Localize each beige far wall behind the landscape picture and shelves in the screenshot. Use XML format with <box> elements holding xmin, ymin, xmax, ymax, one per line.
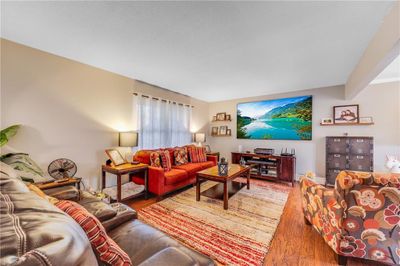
<box><xmin>208</xmin><ymin>82</ymin><xmax>400</xmax><ymax>179</ymax></box>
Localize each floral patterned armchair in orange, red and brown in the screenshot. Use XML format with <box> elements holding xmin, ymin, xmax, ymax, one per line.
<box><xmin>300</xmin><ymin>171</ymin><xmax>400</xmax><ymax>265</ymax></box>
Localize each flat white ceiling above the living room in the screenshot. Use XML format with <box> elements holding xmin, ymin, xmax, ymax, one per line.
<box><xmin>1</xmin><ymin>1</ymin><xmax>393</xmax><ymax>101</ymax></box>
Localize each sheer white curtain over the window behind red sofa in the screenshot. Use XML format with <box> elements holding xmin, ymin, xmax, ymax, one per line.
<box><xmin>133</xmin><ymin>95</ymin><xmax>191</xmax><ymax>149</ymax></box>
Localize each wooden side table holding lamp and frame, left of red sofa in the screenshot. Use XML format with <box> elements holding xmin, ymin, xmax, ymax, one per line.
<box><xmin>101</xmin><ymin>163</ymin><xmax>148</xmax><ymax>202</ymax></box>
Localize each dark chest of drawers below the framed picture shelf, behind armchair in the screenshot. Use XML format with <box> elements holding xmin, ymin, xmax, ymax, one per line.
<box><xmin>326</xmin><ymin>136</ymin><xmax>374</xmax><ymax>186</ymax></box>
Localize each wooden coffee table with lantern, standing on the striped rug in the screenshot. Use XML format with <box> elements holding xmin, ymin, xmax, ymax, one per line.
<box><xmin>196</xmin><ymin>164</ymin><xmax>251</xmax><ymax>210</ymax></box>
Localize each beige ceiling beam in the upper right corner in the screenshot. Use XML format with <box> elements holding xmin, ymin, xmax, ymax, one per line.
<box><xmin>346</xmin><ymin>1</ymin><xmax>400</xmax><ymax>99</ymax></box>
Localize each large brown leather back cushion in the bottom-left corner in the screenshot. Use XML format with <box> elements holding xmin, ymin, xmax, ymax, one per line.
<box><xmin>0</xmin><ymin>173</ymin><xmax>97</xmax><ymax>266</ymax></box>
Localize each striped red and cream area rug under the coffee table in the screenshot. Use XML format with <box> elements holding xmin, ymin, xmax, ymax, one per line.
<box><xmin>139</xmin><ymin>179</ymin><xmax>291</xmax><ymax>265</ymax></box>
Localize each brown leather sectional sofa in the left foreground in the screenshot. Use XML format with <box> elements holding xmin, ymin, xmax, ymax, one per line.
<box><xmin>0</xmin><ymin>172</ymin><xmax>215</xmax><ymax>266</ymax></box>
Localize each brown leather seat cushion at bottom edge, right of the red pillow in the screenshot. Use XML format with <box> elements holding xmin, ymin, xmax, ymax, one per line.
<box><xmin>108</xmin><ymin>220</ymin><xmax>215</xmax><ymax>266</ymax></box>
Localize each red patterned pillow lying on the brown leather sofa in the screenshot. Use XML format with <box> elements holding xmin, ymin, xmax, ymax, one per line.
<box><xmin>56</xmin><ymin>200</ymin><xmax>132</xmax><ymax>266</ymax></box>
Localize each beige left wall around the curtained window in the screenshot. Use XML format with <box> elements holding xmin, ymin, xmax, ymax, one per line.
<box><xmin>1</xmin><ymin>40</ymin><xmax>208</xmax><ymax>187</ymax></box>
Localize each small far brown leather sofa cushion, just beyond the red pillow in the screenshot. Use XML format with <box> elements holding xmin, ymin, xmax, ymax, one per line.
<box><xmin>78</xmin><ymin>191</ymin><xmax>117</xmax><ymax>222</ymax></box>
